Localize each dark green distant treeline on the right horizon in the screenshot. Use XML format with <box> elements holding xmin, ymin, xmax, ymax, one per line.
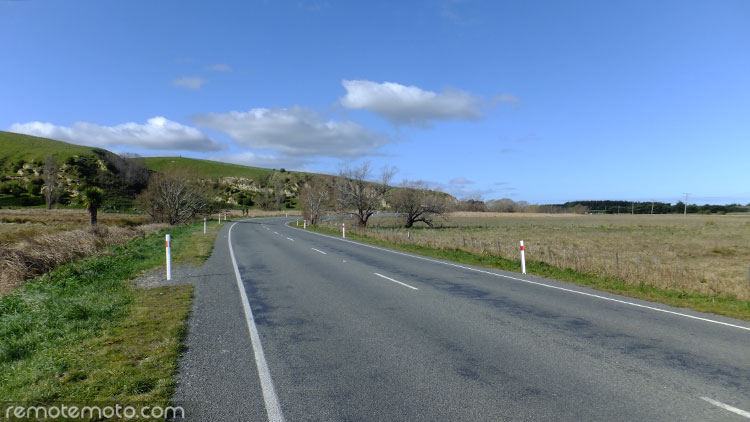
<box><xmin>560</xmin><ymin>201</ymin><xmax>750</xmax><ymax>214</ymax></box>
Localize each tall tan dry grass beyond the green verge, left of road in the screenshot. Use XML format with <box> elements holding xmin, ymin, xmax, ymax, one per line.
<box><xmin>0</xmin><ymin>224</ymin><xmax>165</xmax><ymax>294</ymax></box>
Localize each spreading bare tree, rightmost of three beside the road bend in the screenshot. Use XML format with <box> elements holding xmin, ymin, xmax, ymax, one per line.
<box><xmin>391</xmin><ymin>180</ymin><xmax>448</xmax><ymax>228</ymax></box>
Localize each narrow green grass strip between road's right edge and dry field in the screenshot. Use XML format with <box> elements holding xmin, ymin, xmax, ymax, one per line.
<box><xmin>308</xmin><ymin>226</ymin><xmax>750</xmax><ymax>321</ymax></box>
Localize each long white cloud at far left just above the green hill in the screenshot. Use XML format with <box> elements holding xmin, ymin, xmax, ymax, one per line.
<box><xmin>9</xmin><ymin>117</ymin><xmax>223</xmax><ymax>151</ymax></box>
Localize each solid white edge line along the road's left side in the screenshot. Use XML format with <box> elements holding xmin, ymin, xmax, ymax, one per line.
<box><xmin>227</xmin><ymin>223</ymin><xmax>284</xmax><ymax>422</ymax></box>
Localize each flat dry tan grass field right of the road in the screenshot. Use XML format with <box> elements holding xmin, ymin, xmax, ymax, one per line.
<box><xmin>326</xmin><ymin>212</ymin><xmax>750</xmax><ymax>299</ymax></box>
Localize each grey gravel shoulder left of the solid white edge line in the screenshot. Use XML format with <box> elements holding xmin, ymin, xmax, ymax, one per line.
<box><xmin>170</xmin><ymin>224</ymin><xmax>266</xmax><ymax>421</ymax></box>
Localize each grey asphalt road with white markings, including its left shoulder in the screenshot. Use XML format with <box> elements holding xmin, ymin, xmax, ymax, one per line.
<box><xmin>175</xmin><ymin>219</ymin><xmax>750</xmax><ymax>421</ymax></box>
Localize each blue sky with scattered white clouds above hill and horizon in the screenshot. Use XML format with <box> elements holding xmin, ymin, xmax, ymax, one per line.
<box><xmin>0</xmin><ymin>0</ymin><xmax>750</xmax><ymax>203</ymax></box>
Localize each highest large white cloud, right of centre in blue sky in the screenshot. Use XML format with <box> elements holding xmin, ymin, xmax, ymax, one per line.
<box><xmin>341</xmin><ymin>80</ymin><xmax>481</xmax><ymax>127</ymax></box>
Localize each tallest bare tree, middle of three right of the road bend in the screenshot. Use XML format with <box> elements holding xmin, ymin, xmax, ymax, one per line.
<box><xmin>336</xmin><ymin>162</ymin><xmax>396</xmax><ymax>227</ymax></box>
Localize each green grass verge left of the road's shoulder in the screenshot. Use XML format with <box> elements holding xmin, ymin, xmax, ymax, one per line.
<box><xmin>0</xmin><ymin>222</ymin><xmax>218</xmax><ymax>414</ymax></box>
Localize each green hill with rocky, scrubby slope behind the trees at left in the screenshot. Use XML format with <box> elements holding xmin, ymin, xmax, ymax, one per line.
<box><xmin>0</xmin><ymin>131</ymin><xmax>308</xmax><ymax>209</ymax></box>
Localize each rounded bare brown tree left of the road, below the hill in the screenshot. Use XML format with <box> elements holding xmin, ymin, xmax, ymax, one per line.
<box><xmin>137</xmin><ymin>170</ymin><xmax>211</xmax><ymax>225</ymax></box>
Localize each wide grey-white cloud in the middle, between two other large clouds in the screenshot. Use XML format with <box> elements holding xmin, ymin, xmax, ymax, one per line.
<box><xmin>193</xmin><ymin>106</ymin><xmax>392</xmax><ymax>157</ymax></box>
